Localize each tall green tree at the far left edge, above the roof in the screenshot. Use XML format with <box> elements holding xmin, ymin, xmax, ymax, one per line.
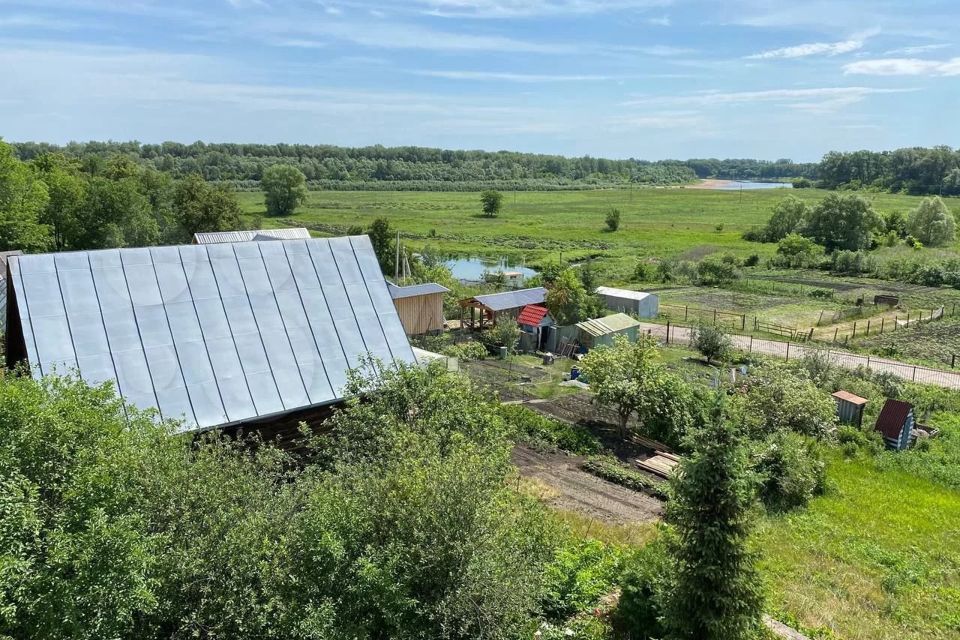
<box><xmin>0</xmin><ymin>140</ymin><xmax>51</xmax><ymax>251</ymax></box>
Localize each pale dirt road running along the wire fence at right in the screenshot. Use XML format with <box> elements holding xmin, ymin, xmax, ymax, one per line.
<box><xmin>640</xmin><ymin>322</ymin><xmax>960</xmax><ymax>389</ymax></box>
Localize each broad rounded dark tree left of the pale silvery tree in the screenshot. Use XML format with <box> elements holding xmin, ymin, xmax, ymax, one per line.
<box><xmin>801</xmin><ymin>193</ymin><xmax>884</xmax><ymax>252</ymax></box>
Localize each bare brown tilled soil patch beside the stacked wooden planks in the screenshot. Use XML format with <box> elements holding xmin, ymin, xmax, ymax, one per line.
<box><xmin>513</xmin><ymin>447</ymin><xmax>663</xmax><ymax>524</ymax></box>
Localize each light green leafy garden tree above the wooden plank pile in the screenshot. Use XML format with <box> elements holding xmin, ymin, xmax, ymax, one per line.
<box><xmin>580</xmin><ymin>335</ymin><xmax>695</xmax><ymax>444</ymax></box>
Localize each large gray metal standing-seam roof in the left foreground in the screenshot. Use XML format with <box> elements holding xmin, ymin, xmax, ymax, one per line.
<box><xmin>10</xmin><ymin>236</ymin><xmax>414</xmax><ymax>429</ymax></box>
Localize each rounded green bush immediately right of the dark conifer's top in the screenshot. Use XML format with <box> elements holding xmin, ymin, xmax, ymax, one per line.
<box><xmin>753</xmin><ymin>432</ymin><xmax>826</xmax><ymax>511</ymax></box>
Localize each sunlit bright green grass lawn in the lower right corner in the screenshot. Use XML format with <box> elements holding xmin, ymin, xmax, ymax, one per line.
<box><xmin>759</xmin><ymin>458</ymin><xmax>960</xmax><ymax>640</ymax></box>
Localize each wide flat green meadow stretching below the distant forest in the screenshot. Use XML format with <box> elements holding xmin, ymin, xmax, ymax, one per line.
<box><xmin>239</xmin><ymin>188</ymin><xmax>932</xmax><ymax>275</ymax></box>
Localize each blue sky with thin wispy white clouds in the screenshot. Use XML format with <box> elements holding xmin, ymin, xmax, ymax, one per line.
<box><xmin>0</xmin><ymin>0</ymin><xmax>960</xmax><ymax>161</ymax></box>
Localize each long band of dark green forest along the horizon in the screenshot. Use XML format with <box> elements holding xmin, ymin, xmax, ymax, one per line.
<box><xmin>13</xmin><ymin>142</ymin><xmax>960</xmax><ymax>195</ymax></box>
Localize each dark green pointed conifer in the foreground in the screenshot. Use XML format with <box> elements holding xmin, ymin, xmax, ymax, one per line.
<box><xmin>664</xmin><ymin>396</ymin><xmax>763</xmax><ymax>640</ymax></box>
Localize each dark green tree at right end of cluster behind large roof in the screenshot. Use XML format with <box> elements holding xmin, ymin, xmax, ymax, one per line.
<box><xmin>173</xmin><ymin>173</ymin><xmax>241</xmax><ymax>242</ymax></box>
